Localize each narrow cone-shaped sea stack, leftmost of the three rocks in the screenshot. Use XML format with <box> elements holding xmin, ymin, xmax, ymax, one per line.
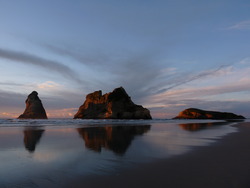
<box><xmin>18</xmin><ymin>91</ymin><xmax>48</xmax><ymax>119</ymax></box>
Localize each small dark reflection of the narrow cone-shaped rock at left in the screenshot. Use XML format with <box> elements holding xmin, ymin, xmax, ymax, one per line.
<box><xmin>23</xmin><ymin>128</ymin><xmax>44</xmax><ymax>152</ymax></box>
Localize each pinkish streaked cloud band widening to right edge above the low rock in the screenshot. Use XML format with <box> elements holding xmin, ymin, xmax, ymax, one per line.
<box><xmin>150</xmin><ymin>64</ymin><xmax>250</xmax><ymax>103</ymax></box>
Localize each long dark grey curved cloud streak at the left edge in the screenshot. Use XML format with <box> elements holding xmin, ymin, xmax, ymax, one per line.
<box><xmin>0</xmin><ymin>48</ymin><xmax>83</xmax><ymax>83</ymax></box>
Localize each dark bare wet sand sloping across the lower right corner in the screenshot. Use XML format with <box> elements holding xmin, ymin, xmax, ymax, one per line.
<box><xmin>65</xmin><ymin>123</ymin><xmax>250</xmax><ymax>188</ymax></box>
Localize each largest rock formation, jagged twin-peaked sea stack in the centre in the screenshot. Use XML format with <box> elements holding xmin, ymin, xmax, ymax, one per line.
<box><xmin>74</xmin><ymin>87</ymin><xmax>152</xmax><ymax>119</ymax></box>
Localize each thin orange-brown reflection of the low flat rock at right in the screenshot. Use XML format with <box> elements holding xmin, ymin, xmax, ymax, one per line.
<box><xmin>179</xmin><ymin>122</ymin><xmax>228</xmax><ymax>131</ymax></box>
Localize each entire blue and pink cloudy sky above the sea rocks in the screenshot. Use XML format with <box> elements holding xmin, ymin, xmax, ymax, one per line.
<box><xmin>0</xmin><ymin>0</ymin><xmax>250</xmax><ymax>118</ymax></box>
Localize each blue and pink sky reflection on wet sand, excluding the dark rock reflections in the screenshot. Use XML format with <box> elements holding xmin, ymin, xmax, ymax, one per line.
<box><xmin>0</xmin><ymin>123</ymin><xmax>236</xmax><ymax>187</ymax></box>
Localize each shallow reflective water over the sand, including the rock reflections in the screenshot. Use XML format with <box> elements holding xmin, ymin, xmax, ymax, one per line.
<box><xmin>0</xmin><ymin>119</ymin><xmax>237</xmax><ymax>188</ymax></box>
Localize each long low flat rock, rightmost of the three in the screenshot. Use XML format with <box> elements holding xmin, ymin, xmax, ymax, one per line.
<box><xmin>174</xmin><ymin>108</ymin><xmax>245</xmax><ymax>120</ymax></box>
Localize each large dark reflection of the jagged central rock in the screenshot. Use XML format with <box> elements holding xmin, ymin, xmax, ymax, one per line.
<box><xmin>77</xmin><ymin>125</ymin><xmax>150</xmax><ymax>155</ymax></box>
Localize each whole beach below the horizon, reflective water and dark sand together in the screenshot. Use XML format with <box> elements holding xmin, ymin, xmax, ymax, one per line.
<box><xmin>0</xmin><ymin>119</ymin><xmax>250</xmax><ymax>188</ymax></box>
